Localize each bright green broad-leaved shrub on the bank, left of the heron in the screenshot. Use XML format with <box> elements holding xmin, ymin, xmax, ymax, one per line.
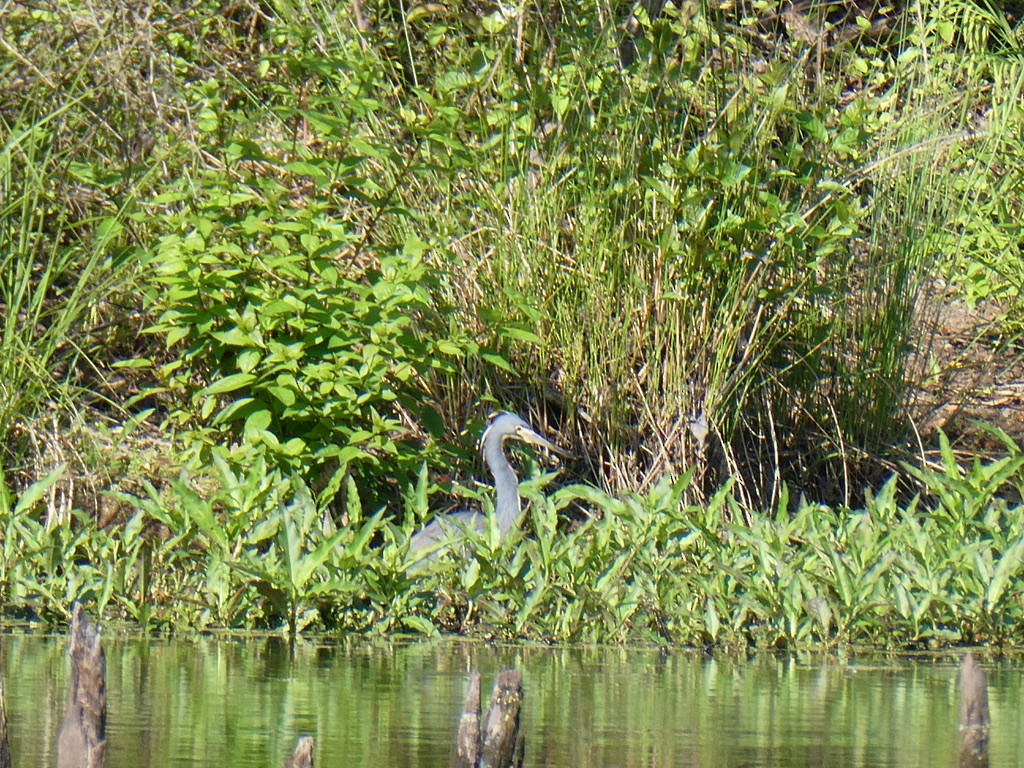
<box><xmin>142</xmin><ymin>134</ymin><xmax>469</xmax><ymax>507</ymax></box>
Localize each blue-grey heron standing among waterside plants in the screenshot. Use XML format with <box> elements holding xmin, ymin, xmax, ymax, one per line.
<box><xmin>409</xmin><ymin>413</ymin><xmax>566</xmax><ymax>562</ymax></box>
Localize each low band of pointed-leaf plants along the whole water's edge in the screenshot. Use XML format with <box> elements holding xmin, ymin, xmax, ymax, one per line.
<box><xmin>12</xmin><ymin>436</ymin><xmax>1024</xmax><ymax>650</ymax></box>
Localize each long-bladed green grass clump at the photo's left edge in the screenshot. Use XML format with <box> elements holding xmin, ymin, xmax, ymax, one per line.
<box><xmin>0</xmin><ymin>104</ymin><xmax>133</xmax><ymax>473</ymax></box>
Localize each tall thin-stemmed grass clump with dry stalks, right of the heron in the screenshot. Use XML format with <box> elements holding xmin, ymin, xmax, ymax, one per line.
<box><xmin>397</xmin><ymin>4</ymin><xmax>974</xmax><ymax>506</ymax></box>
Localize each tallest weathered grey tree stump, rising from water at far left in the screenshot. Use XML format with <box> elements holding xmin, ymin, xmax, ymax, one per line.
<box><xmin>57</xmin><ymin>603</ymin><xmax>106</xmax><ymax>768</ymax></box>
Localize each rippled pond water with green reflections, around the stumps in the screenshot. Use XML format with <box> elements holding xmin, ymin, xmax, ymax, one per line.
<box><xmin>0</xmin><ymin>636</ymin><xmax>1024</xmax><ymax>768</ymax></box>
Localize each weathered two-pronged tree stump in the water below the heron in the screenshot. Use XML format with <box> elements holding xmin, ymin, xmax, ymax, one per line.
<box><xmin>452</xmin><ymin>670</ymin><xmax>525</xmax><ymax>768</ymax></box>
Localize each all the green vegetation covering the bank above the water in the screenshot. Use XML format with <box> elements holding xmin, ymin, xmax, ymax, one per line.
<box><xmin>0</xmin><ymin>0</ymin><xmax>1024</xmax><ymax>647</ymax></box>
